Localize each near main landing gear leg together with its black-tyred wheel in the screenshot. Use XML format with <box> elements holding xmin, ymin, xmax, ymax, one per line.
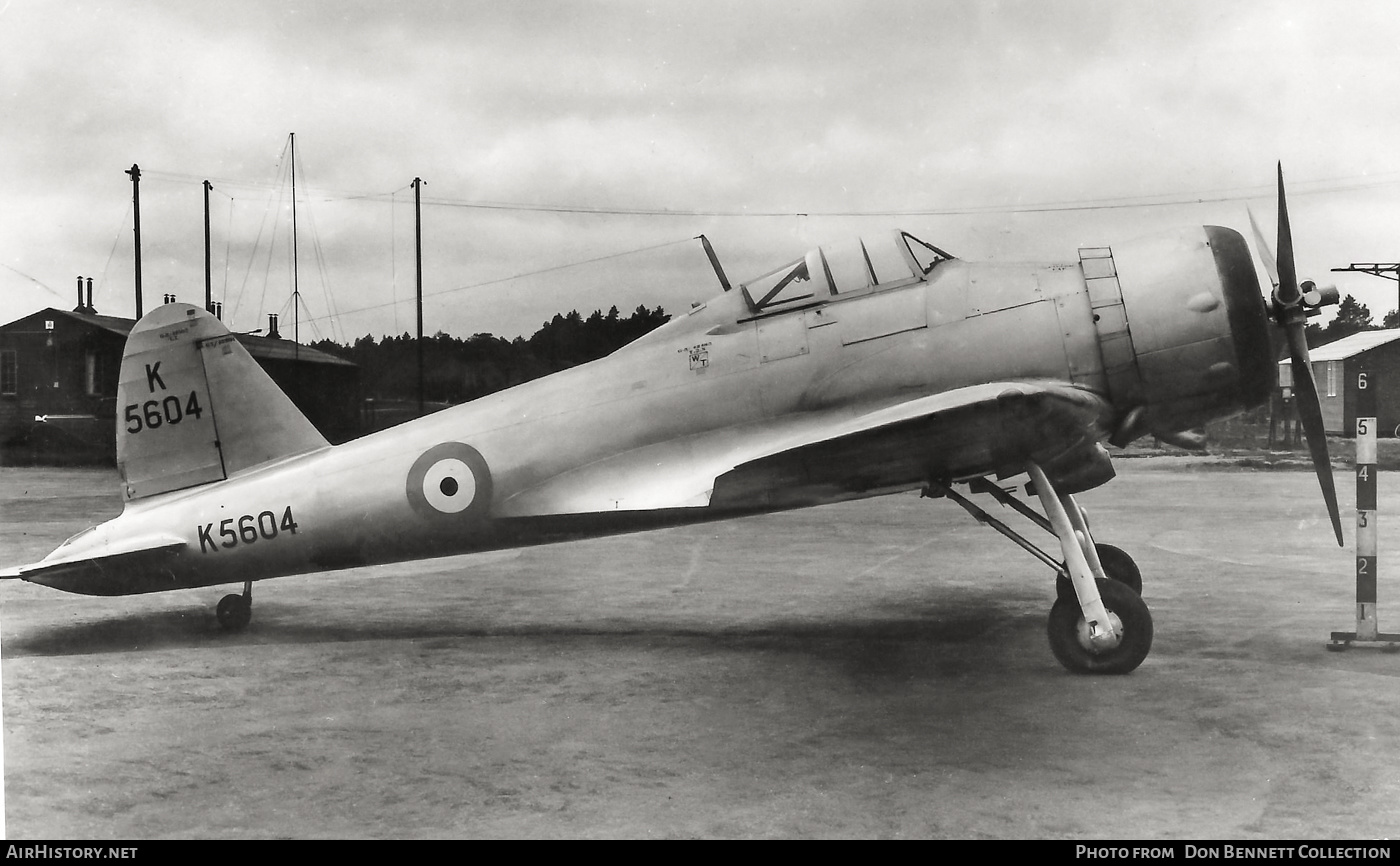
<box><xmin>1026</xmin><ymin>463</ymin><xmax>1152</xmax><ymax>673</ymax></box>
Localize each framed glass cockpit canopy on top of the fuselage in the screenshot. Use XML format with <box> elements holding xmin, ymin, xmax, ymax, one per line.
<box><xmin>741</xmin><ymin>231</ymin><xmax>953</xmax><ymax>315</ymax></box>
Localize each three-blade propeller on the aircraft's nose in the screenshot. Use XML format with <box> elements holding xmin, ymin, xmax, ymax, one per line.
<box><xmin>1249</xmin><ymin>162</ymin><xmax>1343</xmax><ymax>546</ymax></box>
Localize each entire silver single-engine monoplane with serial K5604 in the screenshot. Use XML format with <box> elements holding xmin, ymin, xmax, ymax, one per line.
<box><xmin>0</xmin><ymin>169</ymin><xmax>1341</xmax><ymax>673</ymax></box>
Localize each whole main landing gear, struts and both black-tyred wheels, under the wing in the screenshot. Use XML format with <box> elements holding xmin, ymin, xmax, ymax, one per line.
<box><xmin>924</xmin><ymin>463</ymin><xmax>1152</xmax><ymax>673</ymax></box>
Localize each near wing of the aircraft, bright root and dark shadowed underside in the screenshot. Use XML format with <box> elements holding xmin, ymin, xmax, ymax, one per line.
<box><xmin>496</xmin><ymin>382</ymin><xmax>1112</xmax><ymax>518</ymax></box>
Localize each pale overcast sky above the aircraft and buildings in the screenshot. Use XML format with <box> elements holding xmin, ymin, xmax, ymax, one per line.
<box><xmin>0</xmin><ymin>0</ymin><xmax>1400</xmax><ymax>341</ymax></box>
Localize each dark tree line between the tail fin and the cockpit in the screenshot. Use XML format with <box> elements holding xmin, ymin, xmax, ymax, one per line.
<box><xmin>312</xmin><ymin>306</ymin><xmax>671</xmax><ymax>404</ymax></box>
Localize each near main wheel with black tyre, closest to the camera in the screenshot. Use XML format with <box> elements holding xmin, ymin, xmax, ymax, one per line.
<box><xmin>1046</xmin><ymin>579</ymin><xmax>1152</xmax><ymax>673</ymax></box>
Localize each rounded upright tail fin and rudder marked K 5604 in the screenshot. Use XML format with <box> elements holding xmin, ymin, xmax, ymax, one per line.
<box><xmin>116</xmin><ymin>304</ymin><xmax>329</xmax><ymax>501</ymax></box>
